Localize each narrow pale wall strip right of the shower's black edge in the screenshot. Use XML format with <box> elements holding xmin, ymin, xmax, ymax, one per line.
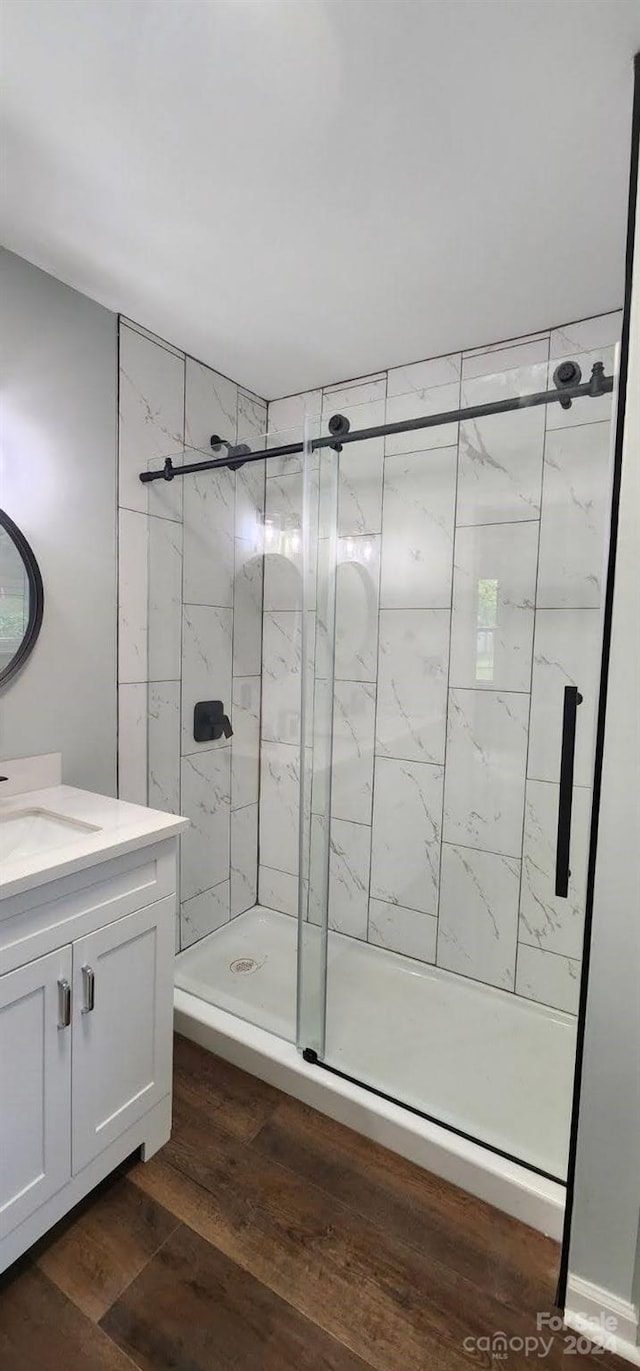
<box><xmin>567</xmin><ymin>150</ymin><xmax>640</xmax><ymax>1327</ymax></box>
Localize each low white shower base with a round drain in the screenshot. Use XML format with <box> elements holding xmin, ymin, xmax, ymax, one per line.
<box><xmin>175</xmin><ymin>906</ymin><xmax>576</xmax><ymax>1238</ymax></box>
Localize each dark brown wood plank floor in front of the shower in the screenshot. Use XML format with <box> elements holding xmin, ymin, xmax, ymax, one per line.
<box><xmin>0</xmin><ymin>1038</ymin><xmax>625</xmax><ymax>1371</ymax></box>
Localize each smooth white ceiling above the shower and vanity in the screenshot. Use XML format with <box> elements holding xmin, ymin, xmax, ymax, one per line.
<box><xmin>0</xmin><ymin>0</ymin><xmax>640</xmax><ymax>398</ymax></box>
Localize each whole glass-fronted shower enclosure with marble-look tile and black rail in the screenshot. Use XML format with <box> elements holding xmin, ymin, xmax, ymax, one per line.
<box><xmin>139</xmin><ymin>314</ymin><xmax>621</xmax><ymax>1200</ymax></box>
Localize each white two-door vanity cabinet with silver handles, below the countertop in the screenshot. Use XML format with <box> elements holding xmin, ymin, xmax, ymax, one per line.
<box><xmin>0</xmin><ymin>802</ymin><xmax>182</xmax><ymax>1271</ymax></box>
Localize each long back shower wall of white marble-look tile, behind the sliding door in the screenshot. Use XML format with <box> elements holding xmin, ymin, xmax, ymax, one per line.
<box><xmin>260</xmin><ymin>313</ymin><xmax>621</xmax><ymax>1013</ymax></box>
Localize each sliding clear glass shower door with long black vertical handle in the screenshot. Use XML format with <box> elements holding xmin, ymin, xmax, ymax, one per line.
<box><xmin>313</xmin><ymin>335</ymin><xmax>619</xmax><ymax>1179</ymax></box>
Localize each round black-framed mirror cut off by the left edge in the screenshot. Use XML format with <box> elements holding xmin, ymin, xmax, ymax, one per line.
<box><xmin>0</xmin><ymin>509</ymin><xmax>44</xmax><ymax>687</ymax></box>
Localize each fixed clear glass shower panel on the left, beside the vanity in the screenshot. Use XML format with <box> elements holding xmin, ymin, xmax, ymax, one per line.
<box><xmin>169</xmin><ymin>414</ymin><xmax>312</xmax><ymax>1041</ymax></box>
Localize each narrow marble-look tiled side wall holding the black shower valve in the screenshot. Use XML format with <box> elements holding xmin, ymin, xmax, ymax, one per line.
<box><xmin>118</xmin><ymin>321</ymin><xmax>266</xmax><ymax>949</ymax></box>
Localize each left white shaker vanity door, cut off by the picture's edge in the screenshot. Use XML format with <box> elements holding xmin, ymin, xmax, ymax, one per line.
<box><xmin>0</xmin><ymin>946</ymin><xmax>71</xmax><ymax>1239</ymax></box>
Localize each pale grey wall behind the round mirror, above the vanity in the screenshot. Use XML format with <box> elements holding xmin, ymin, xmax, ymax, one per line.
<box><xmin>0</xmin><ymin>250</ymin><xmax>116</xmax><ymax>794</ymax></box>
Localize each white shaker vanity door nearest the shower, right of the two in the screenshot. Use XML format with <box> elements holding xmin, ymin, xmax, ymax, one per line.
<box><xmin>73</xmin><ymin>895</ymin><xmax>175</xmax><ymax>1175</ymax></box>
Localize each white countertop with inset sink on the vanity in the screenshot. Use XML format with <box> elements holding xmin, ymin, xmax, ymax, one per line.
<box><xmin>0</xmin><ymin>786</ymin><xmax>189</xmax><ymax>899</ymax></box>
